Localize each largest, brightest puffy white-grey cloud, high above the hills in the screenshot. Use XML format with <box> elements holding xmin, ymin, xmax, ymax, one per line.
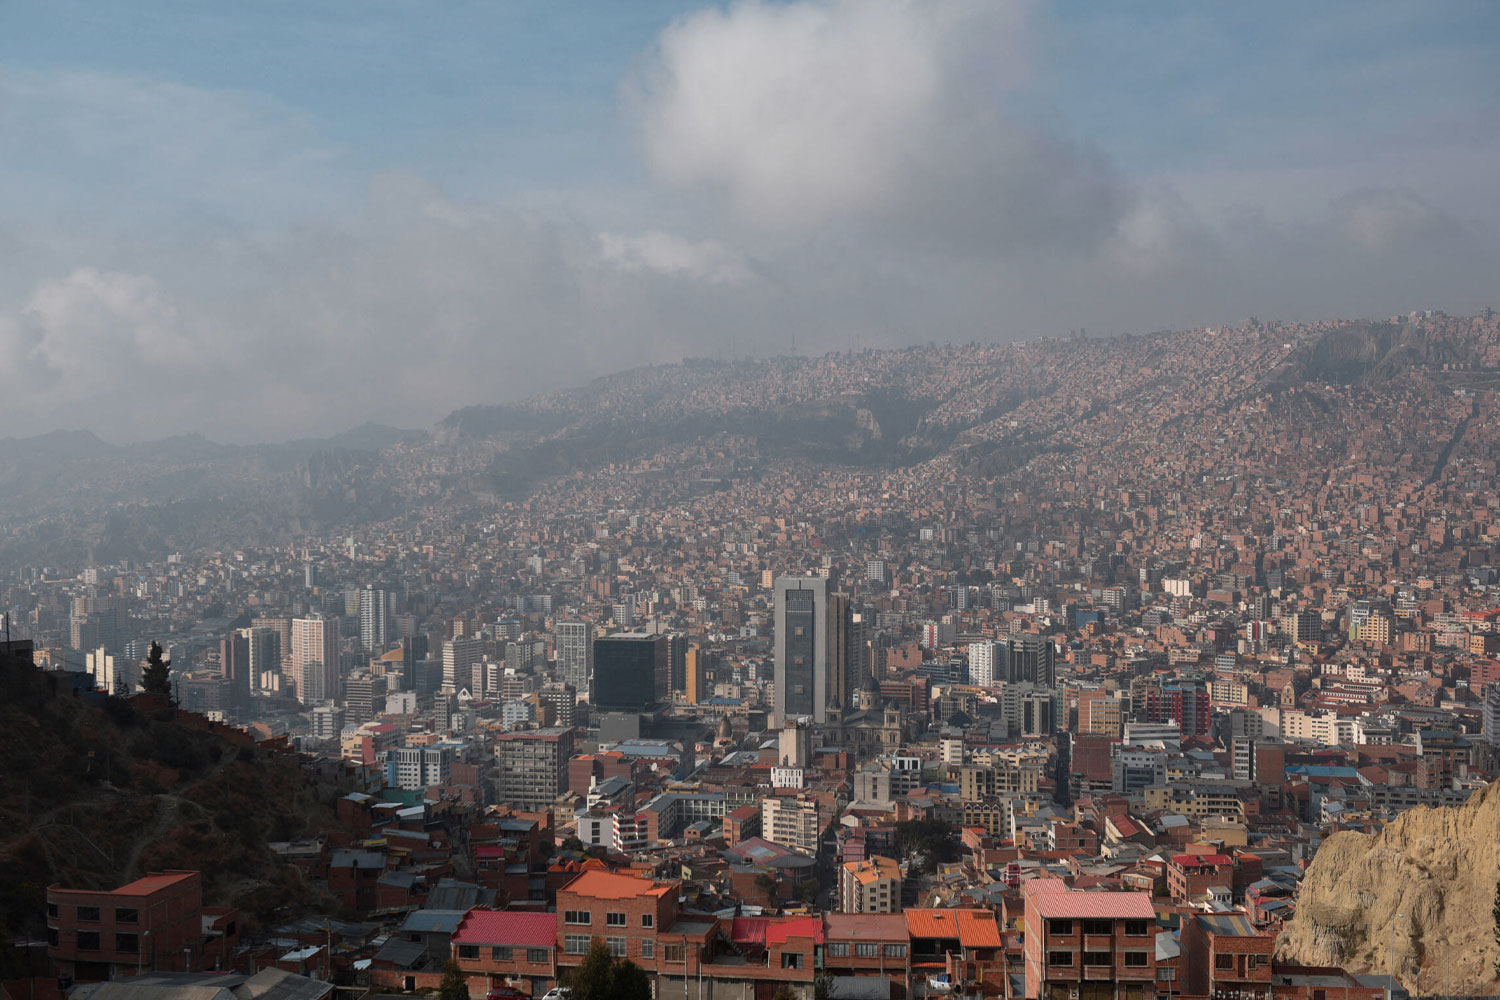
<box><xmin>629</xmin><ymin>0</ymin><xmax>1128</xmax><ymax>250</ymax></box>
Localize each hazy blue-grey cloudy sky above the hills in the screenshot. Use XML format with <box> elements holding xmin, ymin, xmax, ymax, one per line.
<box><xmin>0</xmin><ymin>0</ymin><xmax>1500</xmax><ymax>441</ymax></box>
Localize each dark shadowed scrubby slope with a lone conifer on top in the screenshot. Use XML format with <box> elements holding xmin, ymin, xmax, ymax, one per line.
<box><xmin>0</xmin><ymin>663</ymin><xmax>345</xmax><ymax>966</ymax></box>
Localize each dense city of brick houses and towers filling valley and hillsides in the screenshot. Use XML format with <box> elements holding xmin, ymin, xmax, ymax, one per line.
<box><xmin>0</xmin><ymin>312</ymin><xmax>1500</xmax><ymax>1000</ymax></box>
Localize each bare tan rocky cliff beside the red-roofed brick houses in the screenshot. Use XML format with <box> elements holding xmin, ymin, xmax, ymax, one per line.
<box><xmin>1277</xmin><ymin>786</ymin><xmax>1500</xmax><ymax>994</ymax></box>
